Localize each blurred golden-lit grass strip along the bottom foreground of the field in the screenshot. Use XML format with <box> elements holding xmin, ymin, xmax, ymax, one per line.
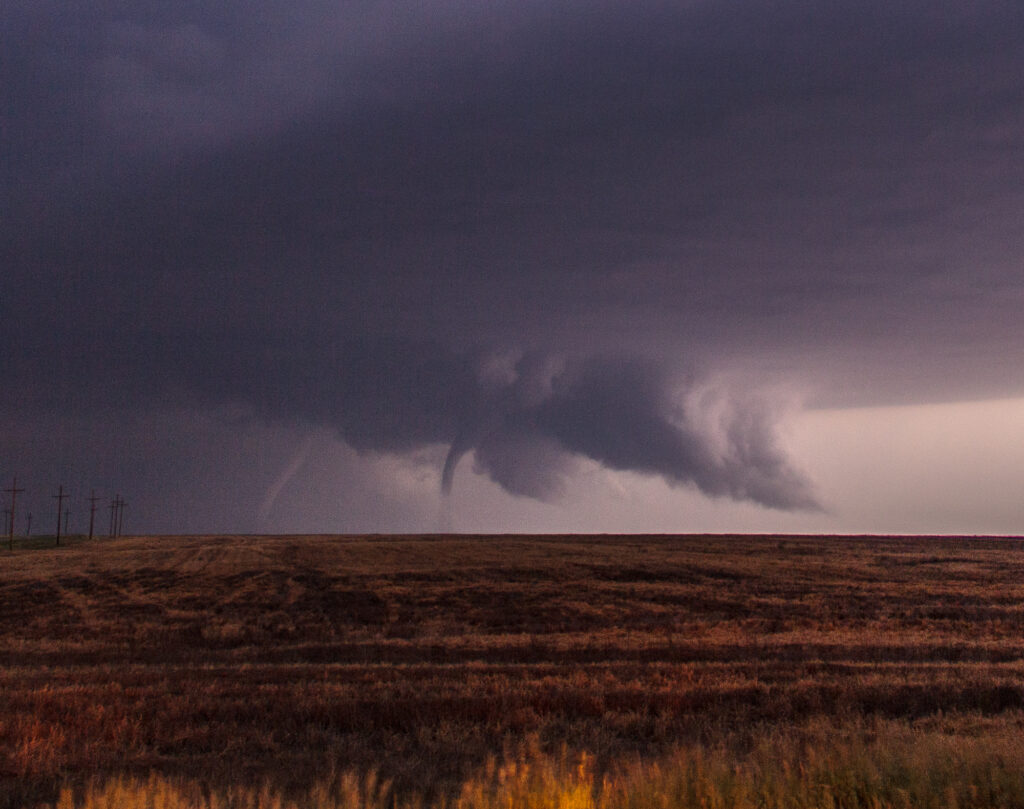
<box><xmin>34</xmin><ymin>723</ymin><xmax>1024</xmax><ymax>809</ymax></box>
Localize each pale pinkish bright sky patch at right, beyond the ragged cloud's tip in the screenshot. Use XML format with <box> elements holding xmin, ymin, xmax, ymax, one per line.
<box><xmin>787</xmin><ymin>398</ymin><xmax>1024</xmax><ymax>535</ymax></box>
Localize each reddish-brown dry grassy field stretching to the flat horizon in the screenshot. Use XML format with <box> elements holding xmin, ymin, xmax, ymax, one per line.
<box><xmin>6</xmin><ymin>536</ymin><xmax>1024</xmax><ymax>807</ymax></box>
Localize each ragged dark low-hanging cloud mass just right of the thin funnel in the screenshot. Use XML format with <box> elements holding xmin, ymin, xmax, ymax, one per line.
<box><xmin>460</xmin><ymin>356</ymin><xmax>819</xmax><ymax>509</ymax></box>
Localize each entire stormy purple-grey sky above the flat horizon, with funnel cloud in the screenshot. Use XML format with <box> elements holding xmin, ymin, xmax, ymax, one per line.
<box><xmin>0</xmin><ymin>0</ymin><xmax>1024</xmax><ymax>533</ymax></box>
